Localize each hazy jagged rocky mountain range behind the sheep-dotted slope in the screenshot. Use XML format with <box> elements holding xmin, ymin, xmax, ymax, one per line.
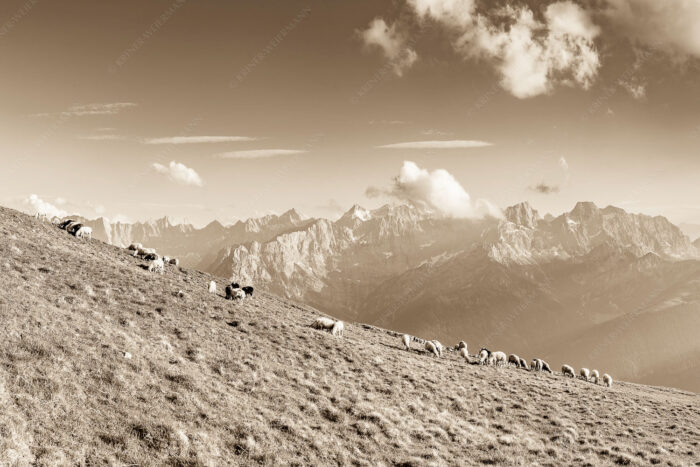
<box><xmin>63</xmin><ymin>202</ymin><xmax>700</xmax><ymax>391</ymax></box>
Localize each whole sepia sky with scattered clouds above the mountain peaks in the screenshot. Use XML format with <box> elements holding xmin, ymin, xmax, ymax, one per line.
<box><xmin>0</xmin><ymin>0</ymin><xmax>700</xmax><ymax>226</ymax></box>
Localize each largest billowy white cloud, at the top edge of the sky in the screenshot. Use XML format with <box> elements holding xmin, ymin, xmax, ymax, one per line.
<box><xmin>408</xmin><ymin>0</ymin><xmax>600</xmax><ymax>99</ymax></box>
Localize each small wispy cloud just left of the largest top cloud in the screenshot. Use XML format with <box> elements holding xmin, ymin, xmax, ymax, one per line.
<box><xmin>357</xmin><ymin>18</ymin><xmax>418</xmax><ymax>76</ymax></box>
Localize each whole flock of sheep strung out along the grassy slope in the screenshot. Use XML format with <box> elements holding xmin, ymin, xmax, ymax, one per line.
<box><xmin>43</xmin><ymin>214</ymin><xmax>613</xmax><ymax>387</ymax></box>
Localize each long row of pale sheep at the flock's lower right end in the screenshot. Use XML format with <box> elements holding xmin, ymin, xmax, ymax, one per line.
<box><xmin>401</xmin><ymin>334</ymin><xmax>613</xmax><ymax>387</ymax></box>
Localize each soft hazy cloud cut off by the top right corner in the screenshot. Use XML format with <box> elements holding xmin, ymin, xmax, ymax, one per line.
<box><xmin>604</xmin><ymin>0</ymin><xmax>700</xmax><ymax>57</ymax></box>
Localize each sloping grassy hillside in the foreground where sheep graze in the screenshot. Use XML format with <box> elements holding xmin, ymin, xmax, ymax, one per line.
<box><xmin>0</xmin><ymin>208</ymin><xmax>700</xmax><ymax>465</ymax></box>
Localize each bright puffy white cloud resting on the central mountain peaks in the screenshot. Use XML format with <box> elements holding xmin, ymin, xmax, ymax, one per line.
<box><xmin>365</xmin><ymin>161</ymin><xmax>502</xmax><ymax>219</ymax></box>
